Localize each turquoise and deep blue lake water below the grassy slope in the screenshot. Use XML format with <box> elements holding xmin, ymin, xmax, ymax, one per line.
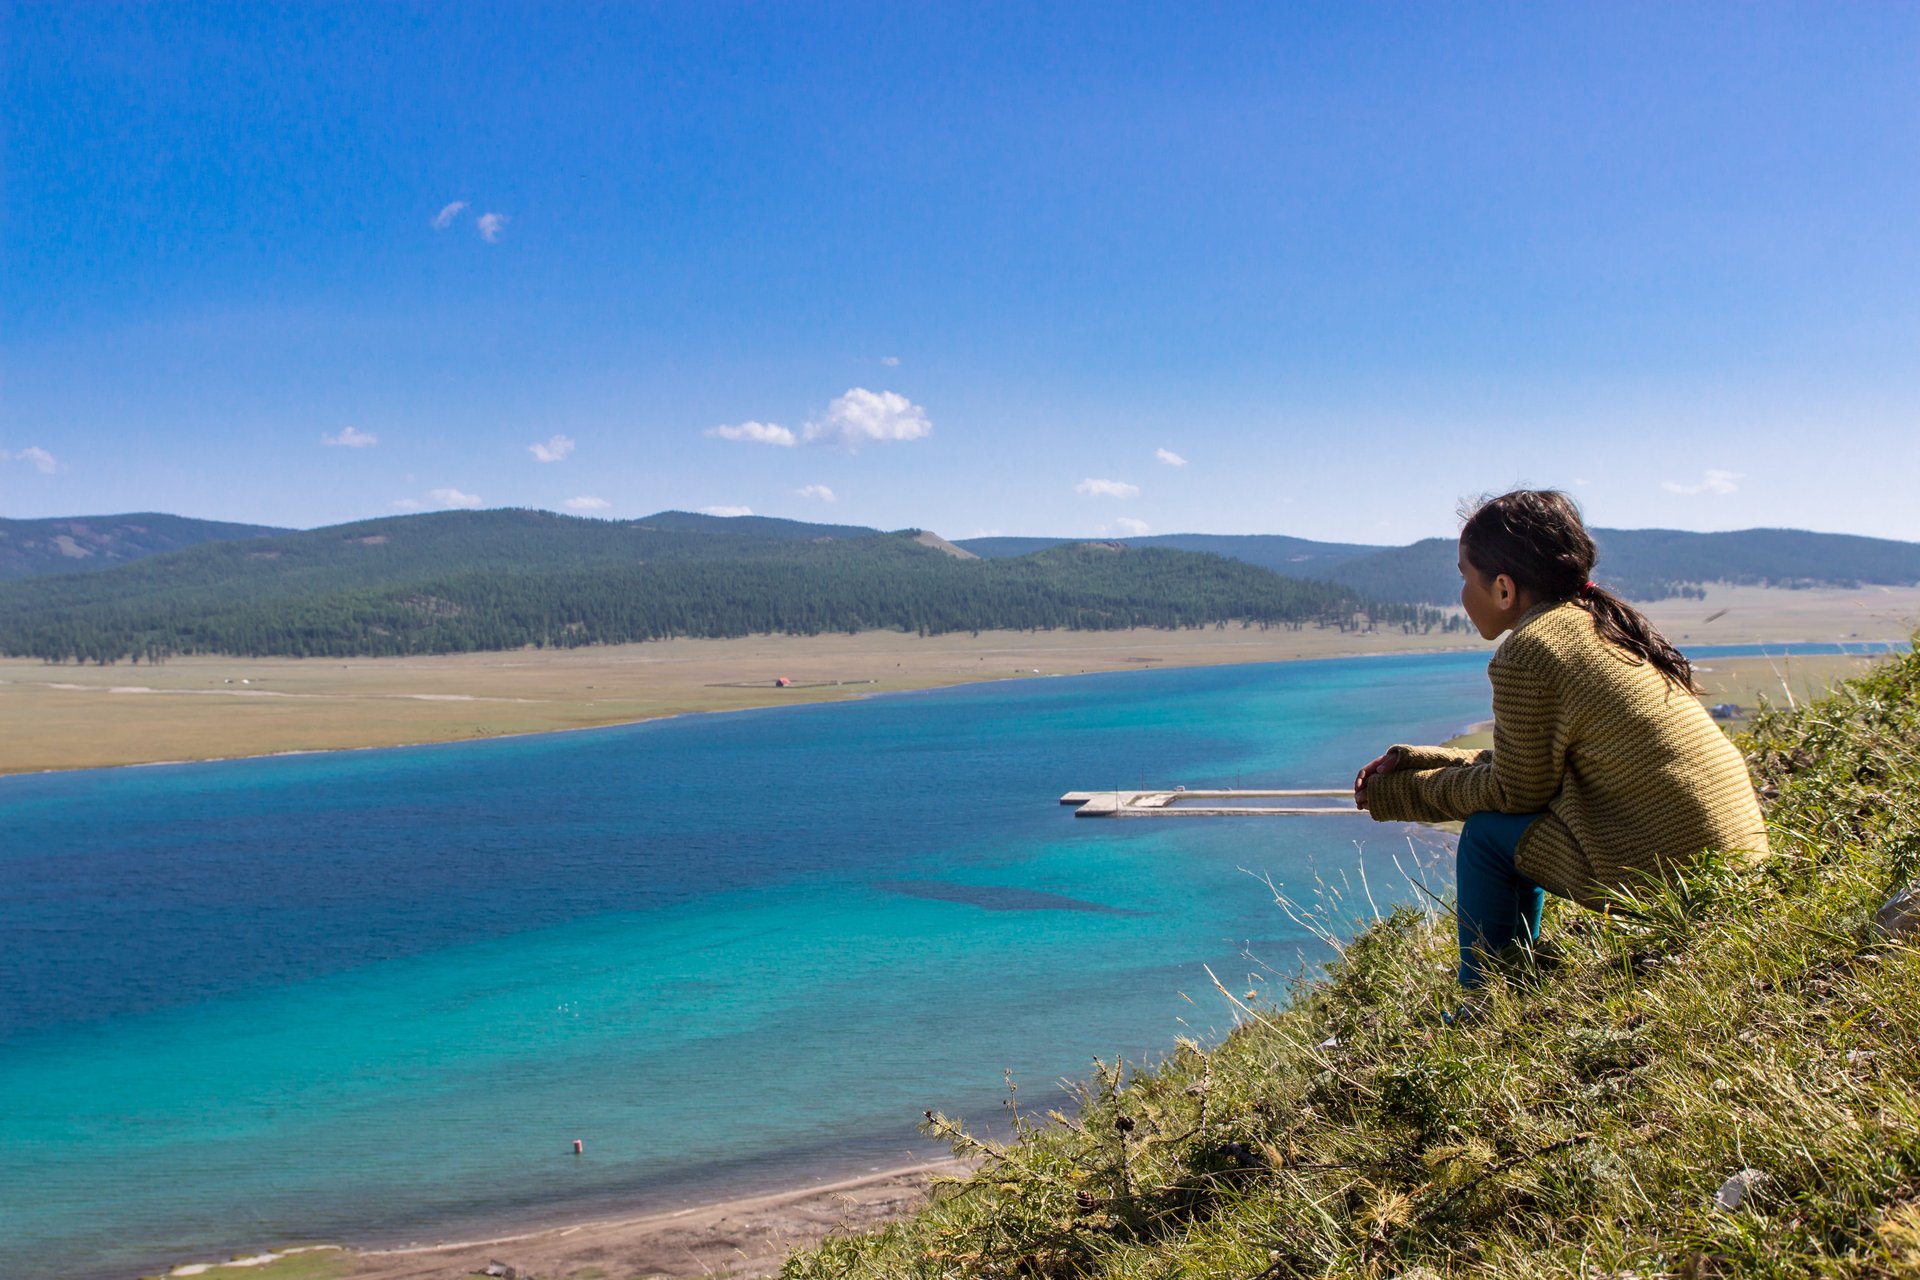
<box><xmin>0</xmin><ymin>647</ymin><xmax>1858</xmax><ymax>1276</ymax></box>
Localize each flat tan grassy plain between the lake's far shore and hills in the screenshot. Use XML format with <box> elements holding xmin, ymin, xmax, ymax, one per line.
<box><xmin>0</xmin><ymin>587</ymin><xmax>1920</xmax><ymax>773</ymax></box>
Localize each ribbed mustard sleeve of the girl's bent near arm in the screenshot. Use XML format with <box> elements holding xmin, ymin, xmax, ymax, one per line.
<box><xmin>1367</xmin><ymin>658</ymin><xmax>1567</xmax><ymax>821</ymax></box>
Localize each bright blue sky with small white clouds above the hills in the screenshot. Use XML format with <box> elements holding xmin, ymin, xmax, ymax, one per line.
<box><xmin>0</xmin><ymin>2</ymin><xmax>1920</xmax><ymax>541</ymax></box>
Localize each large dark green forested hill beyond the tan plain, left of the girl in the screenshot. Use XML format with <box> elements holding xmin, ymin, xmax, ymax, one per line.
<box><xmin>0</xmin><ymin>510</ymin><xmax>1446</xmax><ymax>662</ymax></box>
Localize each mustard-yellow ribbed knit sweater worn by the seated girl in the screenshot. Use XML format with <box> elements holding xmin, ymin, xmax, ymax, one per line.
<box><xmin>1367</xmin><ymin>601</ymin><xmax>1766</xmax><ymax>906</ymax></box>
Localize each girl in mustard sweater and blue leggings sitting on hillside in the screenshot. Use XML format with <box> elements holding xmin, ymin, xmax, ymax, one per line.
<box><xmin>1354</xmin><ymin>489</ymin><xmax>1766</xmax><ymax>986</ymax></box>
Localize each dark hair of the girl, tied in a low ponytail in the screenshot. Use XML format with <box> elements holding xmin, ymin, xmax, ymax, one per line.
<box><xmin>1459</xmin><ymin>489</ymin><xmax>1695</xmax><ymax>693</ymax></box>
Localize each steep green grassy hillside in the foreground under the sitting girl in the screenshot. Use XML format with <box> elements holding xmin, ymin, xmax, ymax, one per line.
<box><xmin>783</xmin><ymin>654</ymin><xmax>1920</xmax><ymax>1280</ymax></box>
